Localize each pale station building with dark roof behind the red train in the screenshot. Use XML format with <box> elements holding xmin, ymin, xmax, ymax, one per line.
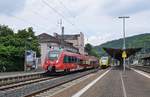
<box><xmin>38</xmin><ymin>33</ymin><xmax>84</xmax><ymax>64</ymax></box>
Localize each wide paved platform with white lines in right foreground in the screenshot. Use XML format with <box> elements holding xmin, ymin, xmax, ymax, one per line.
<box><xmin>52</xmin><ymin>67</ymin><xmax>150</xmax><ymax>97</ymax></box>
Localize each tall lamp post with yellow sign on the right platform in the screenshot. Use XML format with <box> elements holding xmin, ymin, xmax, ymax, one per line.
<box><xmin>118</xmin><ymin>16</ymin><xmax>130</xmax><ymax>71</ymax></box>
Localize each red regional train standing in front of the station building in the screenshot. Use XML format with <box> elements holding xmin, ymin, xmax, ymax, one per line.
<box><xmin>43</xmin><ymin>50</ymin><xmax>99</xmax><ymax>72</ymax></box>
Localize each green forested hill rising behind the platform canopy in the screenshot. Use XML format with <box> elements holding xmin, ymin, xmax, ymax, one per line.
<box><xmin>95</xmin><ymin>33</ymin><xmax>150</xmax><ymax>56</ymax></box>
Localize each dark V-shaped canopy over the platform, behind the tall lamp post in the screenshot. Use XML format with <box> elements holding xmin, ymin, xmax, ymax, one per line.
<box><xmin>103</xmin><ymin>47</ymin><xmax>141</xmax><ymax>60</ymax></box>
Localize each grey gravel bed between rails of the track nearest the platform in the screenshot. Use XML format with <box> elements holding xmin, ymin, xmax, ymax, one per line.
<box><xmin>0</xmin><ymin>70</ymin><xmax>95</xmax><ymax>97</ymax></box>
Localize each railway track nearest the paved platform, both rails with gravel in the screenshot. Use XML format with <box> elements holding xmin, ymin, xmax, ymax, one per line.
<box><xmin>0</xmin><ymin>69</ymin><xmax>96</xmax><ymax>97</ymax></box>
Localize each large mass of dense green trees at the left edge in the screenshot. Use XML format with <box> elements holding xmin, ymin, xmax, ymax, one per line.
<box><xmin>0</xmin><ymin>25</ymin><xmax>40</xmax><ymax>71</ymax></box>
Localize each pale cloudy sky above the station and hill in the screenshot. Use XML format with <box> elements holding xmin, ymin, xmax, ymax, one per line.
<box><xmin>0</xmin><ymin>0</ymin><xmax>150</xmax><ymax>45</ymax></box>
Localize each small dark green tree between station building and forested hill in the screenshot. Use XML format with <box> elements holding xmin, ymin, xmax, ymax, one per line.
<box><xmin>84</xmin><ymin>43</ymin><xmax>100</xmax><ymax>58</ymax></box>
